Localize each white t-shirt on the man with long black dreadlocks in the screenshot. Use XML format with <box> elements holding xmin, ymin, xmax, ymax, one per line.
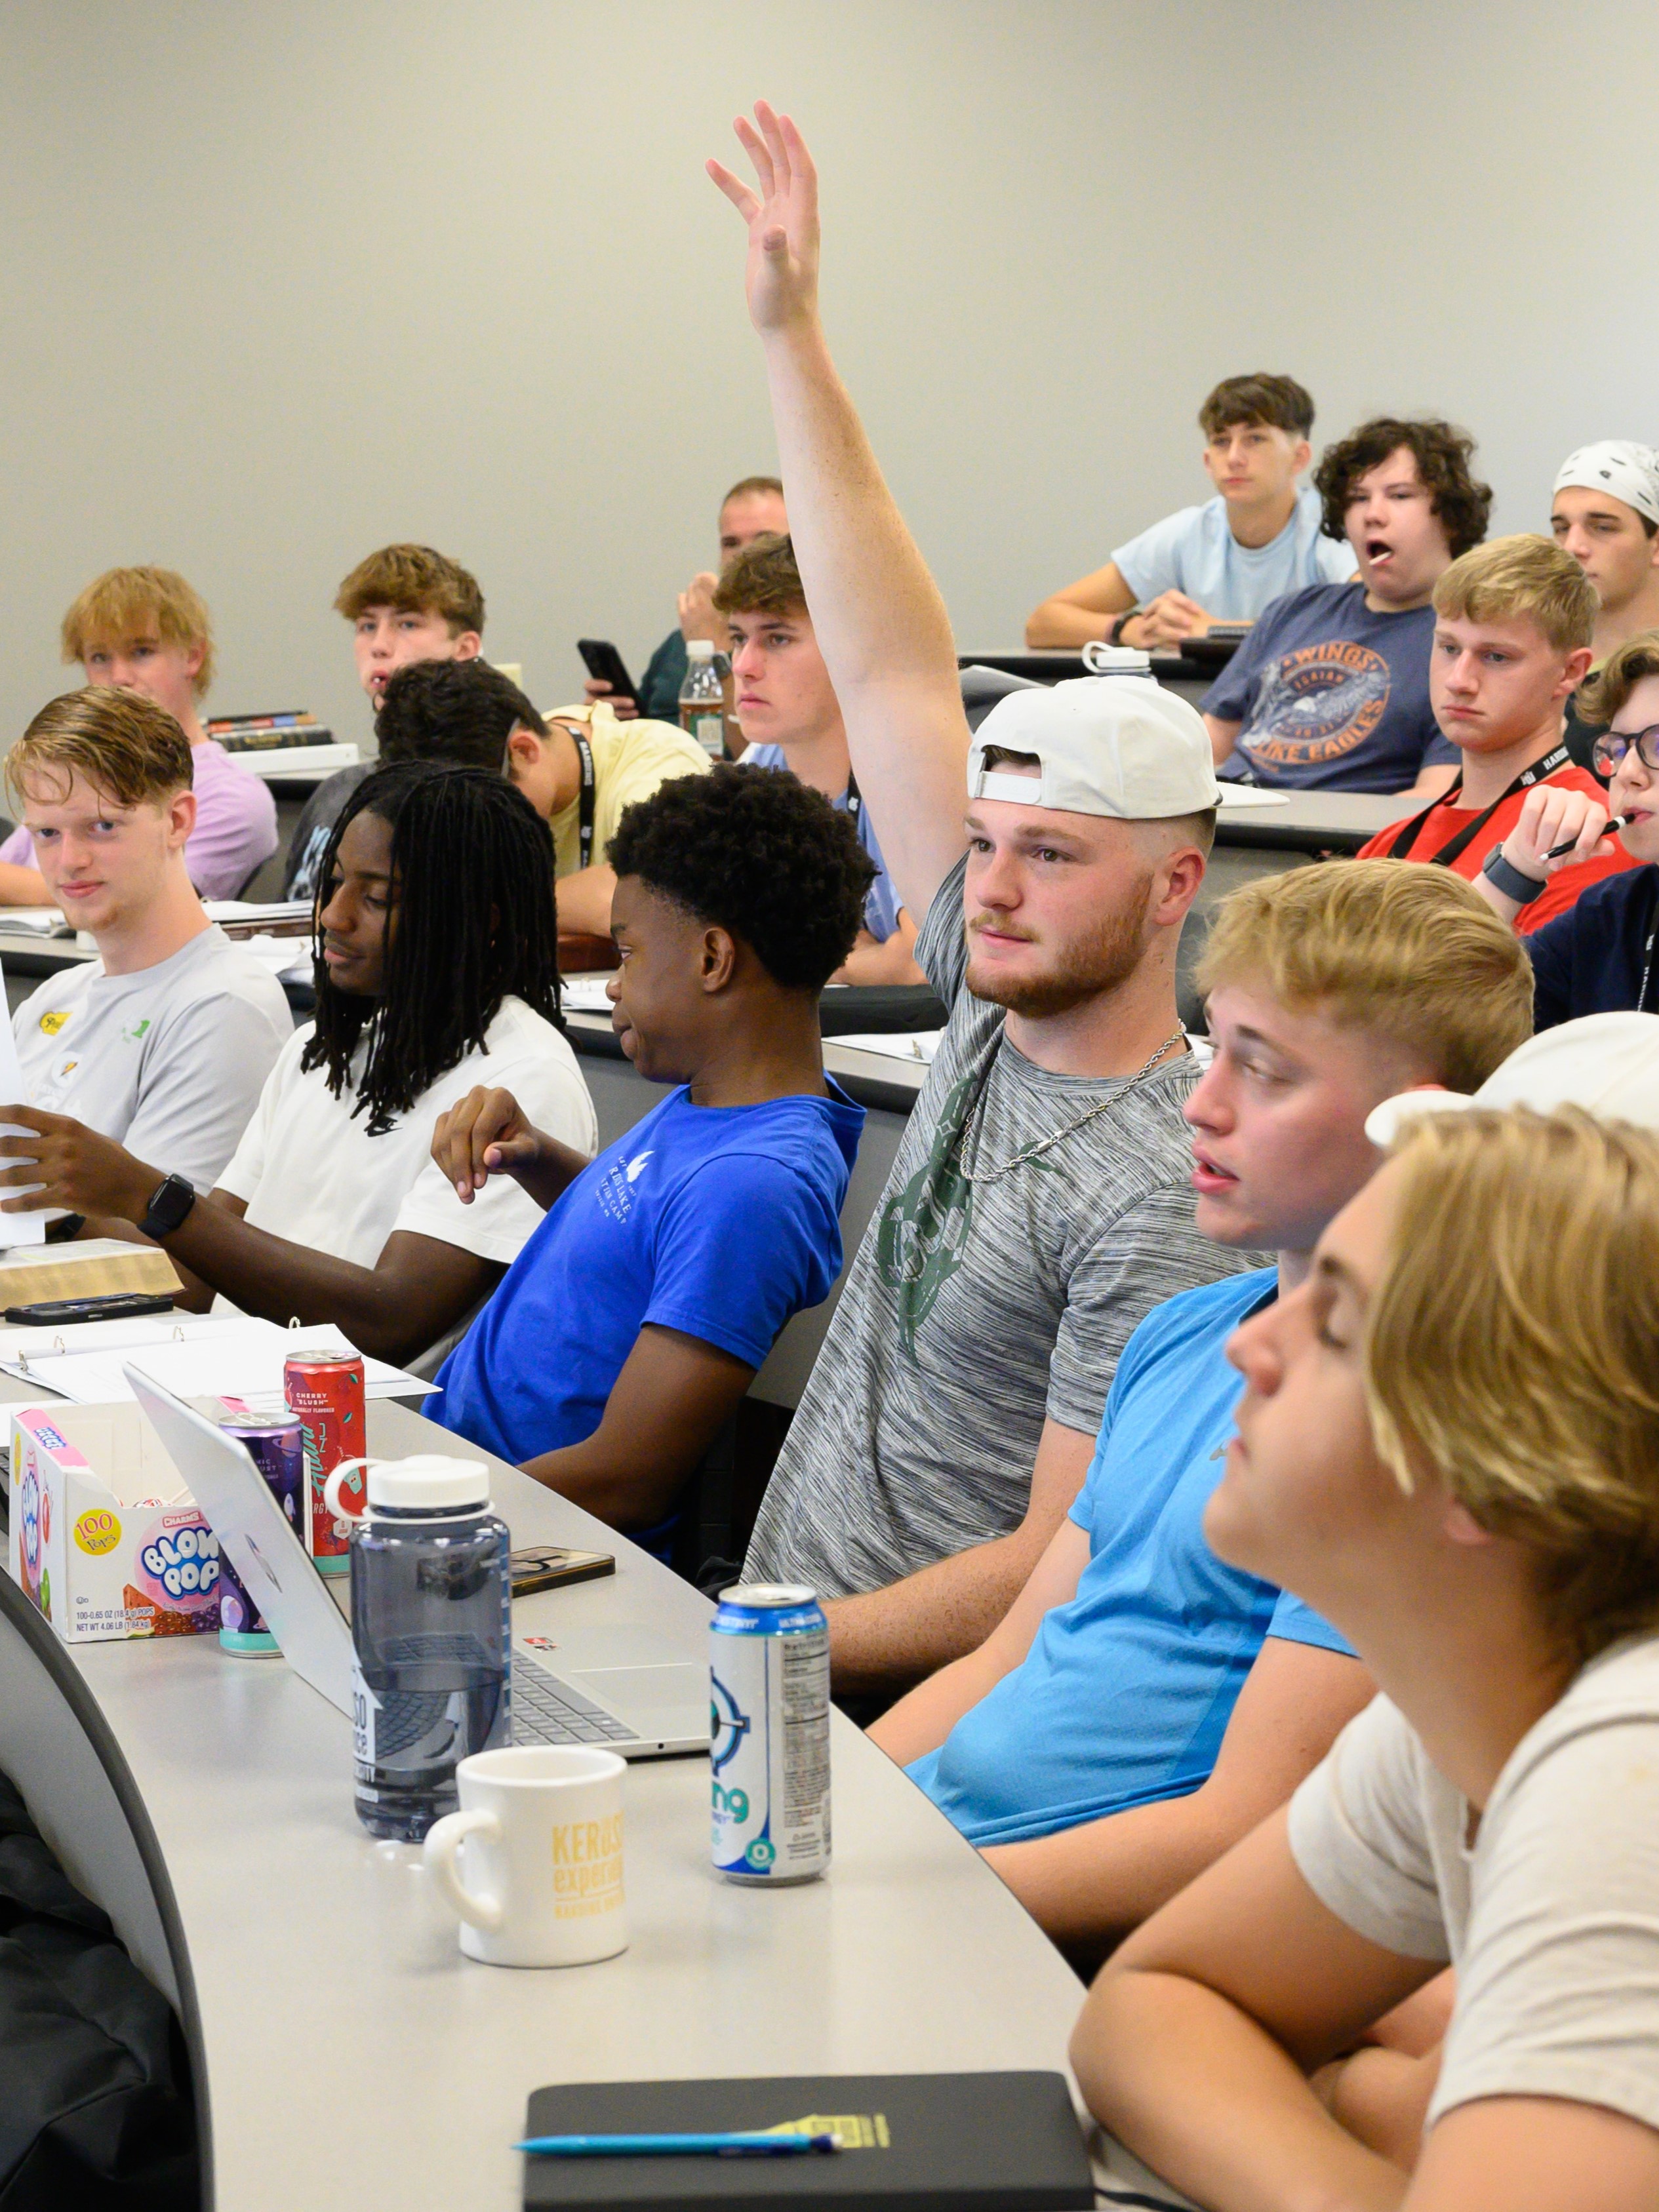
<box><xmin>214</xmin><ymin>998</ymin><xmax>599</xmax><ymax>1312</ymax></box>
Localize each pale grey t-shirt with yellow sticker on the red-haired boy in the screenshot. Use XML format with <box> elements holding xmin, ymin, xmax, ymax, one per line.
<box><xmin>11</xmin><ymin>922</ymin><xmax>294</xmax><ymax>1190</ymax></box>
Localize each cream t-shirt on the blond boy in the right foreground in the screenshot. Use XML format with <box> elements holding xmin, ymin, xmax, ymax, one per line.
<box><xmin>1290</xmin><ymin>1634</ymin><xmax>1659</xmax><ymax>2128</ymax></box>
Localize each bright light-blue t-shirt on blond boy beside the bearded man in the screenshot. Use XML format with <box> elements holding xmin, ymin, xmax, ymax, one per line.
<box><xmin>907</xmin><ymin>1267</ymin><xmax>1349</xmax><ymax>1845</ymax></box>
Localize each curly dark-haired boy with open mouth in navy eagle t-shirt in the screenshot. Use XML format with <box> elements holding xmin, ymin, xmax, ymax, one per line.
<box><xmin>1201</xmin><ymin>416</ymin><xmax>1491</xmax><ymax>805</ymax></box>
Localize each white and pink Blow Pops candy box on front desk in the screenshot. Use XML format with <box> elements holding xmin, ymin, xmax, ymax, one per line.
<box><xmin>9</xmin><ymin>1404</ymin><xmax>219</xmax><ymax>1644</ymax></box>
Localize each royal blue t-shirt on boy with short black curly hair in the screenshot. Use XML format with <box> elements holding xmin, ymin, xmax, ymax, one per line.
<box><xmin>431</xmin><ymin>1084</ymin><xmax>865</xmax><ymax>1465</ymax></box>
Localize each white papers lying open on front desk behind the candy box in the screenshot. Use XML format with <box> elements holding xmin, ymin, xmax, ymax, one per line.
<box><xmin>0</xmin><ymin>1316</ymin><xmax>436</xmax><ymax>1412</ymax></box>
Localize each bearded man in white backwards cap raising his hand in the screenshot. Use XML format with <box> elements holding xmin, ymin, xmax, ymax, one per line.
<box><xmin>710</xmin><ymin>106</ymin><xmax>1239</xmax><ymax>1694</ymax></box>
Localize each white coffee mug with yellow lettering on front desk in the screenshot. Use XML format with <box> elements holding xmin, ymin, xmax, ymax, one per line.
<box><xmin>425</xmin><ymin>1743</ymin><xmax>628</xmax><ymax>1966</ymax></box>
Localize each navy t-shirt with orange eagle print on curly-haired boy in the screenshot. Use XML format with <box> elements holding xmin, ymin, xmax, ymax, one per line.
<box><xmin>1201</xmin><ymin>584</ymin><xmax>1460</xmax><ymax>792</ymax></box>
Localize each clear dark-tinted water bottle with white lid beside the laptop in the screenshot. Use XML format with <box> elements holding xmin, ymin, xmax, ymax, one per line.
<box><xmin>327</xmin><ymin>1455</ymin><xmax>513</xmax><ymax>1843</ymax></box>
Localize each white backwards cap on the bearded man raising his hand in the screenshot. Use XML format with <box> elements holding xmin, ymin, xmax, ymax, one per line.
<box><xmin>969</xmin><ymin>675</ymin><xmax>1221</xmax><ymax>823</ymax></box>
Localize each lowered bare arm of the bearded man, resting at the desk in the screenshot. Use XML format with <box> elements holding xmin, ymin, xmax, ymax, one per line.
<box><xmin>825</xmin><ymin>1420</ymin><xmax>1095</xmax><ymax>1689</ymax></box>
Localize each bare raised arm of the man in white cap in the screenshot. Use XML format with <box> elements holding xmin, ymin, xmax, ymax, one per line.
<box><xmin>708</xmin><ymin>102</ymin><xmax>969</xmax><ymax>922</ymax></box>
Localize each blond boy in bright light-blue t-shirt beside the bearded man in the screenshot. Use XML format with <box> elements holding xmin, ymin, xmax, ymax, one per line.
<box><xmin>871</xmin><ymin>860</ymin><xmax>1530</xmax><ymax>1958</ymax></box>
